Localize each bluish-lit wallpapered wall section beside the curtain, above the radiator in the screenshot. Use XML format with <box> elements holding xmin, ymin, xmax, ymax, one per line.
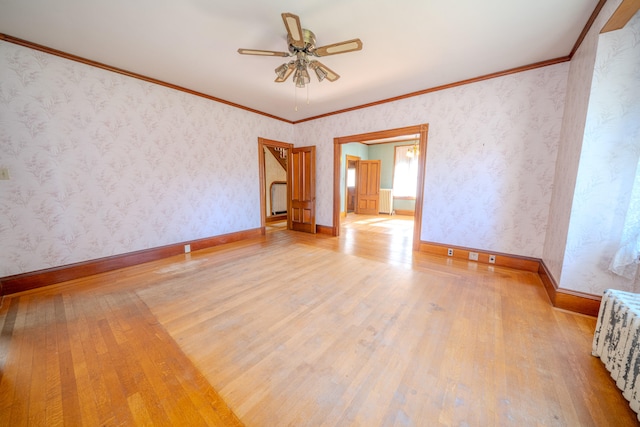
<box><xmin>561</xmin><ymin>8</ymin><xmax>640</xmax><ymax>295</ymax></box>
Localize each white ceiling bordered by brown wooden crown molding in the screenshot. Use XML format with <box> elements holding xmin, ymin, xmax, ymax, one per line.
<box><xmin>0</xmin><ymin>0</ymin><xmax>598</xmax><ymax>122</ymax></box>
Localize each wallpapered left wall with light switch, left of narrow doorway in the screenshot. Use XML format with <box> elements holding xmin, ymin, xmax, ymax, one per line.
<box><xmin>0</xmin><ymin>42</ymin><xmax>293</xmax><ymax>277</ymax></box>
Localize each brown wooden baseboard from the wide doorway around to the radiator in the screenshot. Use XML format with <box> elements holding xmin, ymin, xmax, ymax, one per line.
<box><xmin>420</xmin><ymin>241</ymin><xmax>601</xmax><ymax>317</ymax></box>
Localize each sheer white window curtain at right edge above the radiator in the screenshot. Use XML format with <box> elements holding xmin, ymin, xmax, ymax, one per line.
<box><xmin>609</xmin><ymin>162</ymin><xmax>640</xmax><ymax>279</ymax></box>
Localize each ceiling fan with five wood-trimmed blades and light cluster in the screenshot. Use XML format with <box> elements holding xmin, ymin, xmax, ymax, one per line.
<box><xmin>238</xmin><ymin>13</ymin><xmax>362</xmax><ymax>88</ymax></box>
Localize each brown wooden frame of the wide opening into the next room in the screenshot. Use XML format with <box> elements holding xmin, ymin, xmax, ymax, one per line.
<box><xmin>332</xmin><ymin>123</ymin><xmax>429</xmax><ymax>250</ymax></box>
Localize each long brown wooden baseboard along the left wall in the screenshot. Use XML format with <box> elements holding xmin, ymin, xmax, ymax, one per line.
<box><xmin>0</xmin><ymin>228</ymin><xmax>261</xmax><ymax>295</ymax></box>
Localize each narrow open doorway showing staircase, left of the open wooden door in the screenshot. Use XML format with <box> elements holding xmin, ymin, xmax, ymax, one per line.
<box><xmin>258</xmin><ymin>138</ymin><xmax>292</xmax><ymax>234</ymax></box>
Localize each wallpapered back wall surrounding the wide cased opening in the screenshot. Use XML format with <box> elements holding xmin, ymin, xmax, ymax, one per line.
<box><xmin>295</xmin><ymin>63</ymin><xmax>569</xmax><ymax>257</ymax></box>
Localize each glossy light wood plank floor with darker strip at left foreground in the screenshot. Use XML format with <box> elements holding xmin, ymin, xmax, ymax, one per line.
<box><xmin>0</xmin><ymin>215</ymin><xmax>637</xmax><ymax>426</ymax></box>
